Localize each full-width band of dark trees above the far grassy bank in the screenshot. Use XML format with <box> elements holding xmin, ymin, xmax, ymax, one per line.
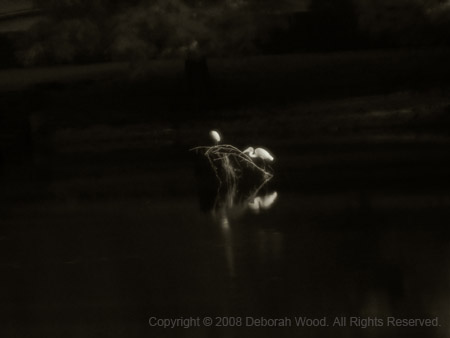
<box><xmin>0</xmin><ymin>0</ymin><xmax>450</xmax><ymax>67</ymax></box>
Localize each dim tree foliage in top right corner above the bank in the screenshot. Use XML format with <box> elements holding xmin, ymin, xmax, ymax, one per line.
<box><xmin>309</xmin><ymin>0</ymin><xmax>450</xmax><ymax>47</ymax></box>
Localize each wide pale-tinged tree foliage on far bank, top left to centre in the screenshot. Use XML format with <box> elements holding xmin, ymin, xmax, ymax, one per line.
<box><xmin>18</xmin><ymin>0</ymin><xmax>294</xmax><ymax>65</ymax></box>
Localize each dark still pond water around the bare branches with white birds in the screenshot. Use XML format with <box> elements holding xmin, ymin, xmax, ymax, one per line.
<box><xmin>0</xmin><ymin>99</ymin><xmax>450</xmax><ymax>337</ymax></box>
